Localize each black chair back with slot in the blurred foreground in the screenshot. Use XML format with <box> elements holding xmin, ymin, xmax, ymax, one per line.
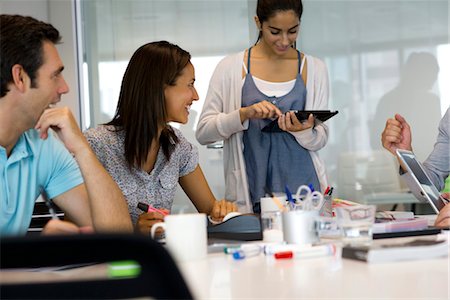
<box><xmin>0</xmin><ymin>234</ymin><xmax>192</xmax><ymax>299</ymax></box>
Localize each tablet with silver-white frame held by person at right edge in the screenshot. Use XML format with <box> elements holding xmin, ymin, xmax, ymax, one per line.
<box><xmin>396</xmin><ymin>149</ymin><xmax>447</xmax><ymax>213</ymax></box>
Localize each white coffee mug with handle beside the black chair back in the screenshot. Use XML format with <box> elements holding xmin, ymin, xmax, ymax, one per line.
<box><xmin>150</xmin><ymin>214</ymin><xmax>208</xmax><ymax>262</ymax></box>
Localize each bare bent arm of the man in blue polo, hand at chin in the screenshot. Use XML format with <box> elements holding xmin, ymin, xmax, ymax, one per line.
<box><xmin>35</xmin><ymin>108</ymin><xmax>133</xmax><ymax>232</ymax></box>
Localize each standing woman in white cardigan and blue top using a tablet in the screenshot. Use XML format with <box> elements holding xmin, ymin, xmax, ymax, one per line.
<box><xmin>196</xmin><ymin>0</ymin><xmax>328</xmax><ymax>212</ymax></box>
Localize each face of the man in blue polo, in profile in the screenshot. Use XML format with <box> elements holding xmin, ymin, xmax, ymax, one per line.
<box><xmin>26</xmin><ymin>42</ymin><xmax>69</xmax><ymax>126</ymax></box>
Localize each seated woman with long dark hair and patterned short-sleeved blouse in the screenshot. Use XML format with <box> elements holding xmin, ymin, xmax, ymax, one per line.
<box><xmin>85</xmin><ymin>41</ymin><xmax>236</xmax><ymax>234</ymax></box>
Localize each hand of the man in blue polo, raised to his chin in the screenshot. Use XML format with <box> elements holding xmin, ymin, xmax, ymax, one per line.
<box><xmin>35</xmin><ymin>107</ymin><xmax>89</xmax><ymax>154</ymax></box>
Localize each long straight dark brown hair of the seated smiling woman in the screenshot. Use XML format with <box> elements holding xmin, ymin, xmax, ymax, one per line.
<box><xmin>106</xmin><ymin>41</ymin><xmax>191</xmax><ymax>168</ymax></box>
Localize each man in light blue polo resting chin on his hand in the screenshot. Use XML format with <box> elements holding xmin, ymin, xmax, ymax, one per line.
<box><xmin>0</xmin><ymin>15</ymin><xmax>132</xmax><ymax>236</ymax></box>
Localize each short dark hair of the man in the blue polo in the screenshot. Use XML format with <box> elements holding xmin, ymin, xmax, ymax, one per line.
<box><xmin>0</xmin><ymin>15</ymin><xmax>61</xmax><ymax>97</ymax></box>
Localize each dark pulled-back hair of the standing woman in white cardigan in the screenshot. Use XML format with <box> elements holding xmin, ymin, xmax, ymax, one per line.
<box><xmin>255</xmin><ymin>0</ymin><xmax>303</xmax><ymax>44</ymax></box>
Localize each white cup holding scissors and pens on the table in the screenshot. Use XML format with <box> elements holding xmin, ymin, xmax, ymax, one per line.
<box><xmin>282</xmin><ymin>210</ymin><xmax>319</xmax><ymax>245</ymax></box>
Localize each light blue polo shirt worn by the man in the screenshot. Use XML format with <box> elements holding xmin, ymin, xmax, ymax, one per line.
<box><xmin>0</xmin><ymin>129</ymin><xmax>83</xmax><ymax>236</ymax></box>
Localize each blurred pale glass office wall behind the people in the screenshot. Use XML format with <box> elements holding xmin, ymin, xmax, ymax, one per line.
<box><xmin>0</xmin><ymin>0</ymin><xmax>450</xmax><ymax>211</ymax></box>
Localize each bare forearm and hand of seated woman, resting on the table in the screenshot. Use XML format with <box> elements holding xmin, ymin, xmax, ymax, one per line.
<box><xmin>179</xmin><ymin>165</ymin><xmax>237</xmax><ymax>221</ymax></box>
